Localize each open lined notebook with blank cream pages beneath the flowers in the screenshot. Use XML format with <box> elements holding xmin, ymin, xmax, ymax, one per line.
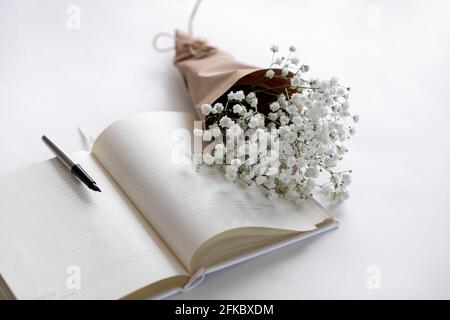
<box><xmin>0</xmin><ymin>112</ymin><xmax>337</xmax><ymax>299</ymax></box>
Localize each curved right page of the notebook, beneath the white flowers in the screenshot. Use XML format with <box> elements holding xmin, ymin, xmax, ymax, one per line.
<box><xmin>93</xmin><ymin>112</ymin><xmax>329</xmax><ymax>268</ymax></box>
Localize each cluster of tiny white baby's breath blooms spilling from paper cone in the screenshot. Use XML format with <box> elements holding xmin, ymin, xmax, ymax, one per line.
<box><xmin>195</xmin><ymin>46</ymin><xmax>359</xmax><ymax>205</ymax></box>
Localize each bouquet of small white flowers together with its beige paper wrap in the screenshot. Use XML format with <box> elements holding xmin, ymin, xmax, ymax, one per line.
<box><xmin>174</xmin><ymin>32</ymin><xmax>358</xmax><ymax>205</ymax></box>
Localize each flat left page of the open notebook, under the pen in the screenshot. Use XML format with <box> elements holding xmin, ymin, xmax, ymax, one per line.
<box><xmin>0</xmin><ymin>152</ymin><xmax>187</xmax><ymax>299</ymax></box>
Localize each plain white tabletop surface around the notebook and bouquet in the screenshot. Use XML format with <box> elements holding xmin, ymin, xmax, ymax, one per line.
<box><xmin>0</xmin><ymin>0</ymin><xmax>450</xmax><ymax>299</ymax></box>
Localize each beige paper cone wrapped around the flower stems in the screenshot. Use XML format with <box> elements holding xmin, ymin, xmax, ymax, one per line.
<box><xmin>174</xmin><ymin>31</ymin><xmax>285</xmax><ymax>124</ymax></box>
